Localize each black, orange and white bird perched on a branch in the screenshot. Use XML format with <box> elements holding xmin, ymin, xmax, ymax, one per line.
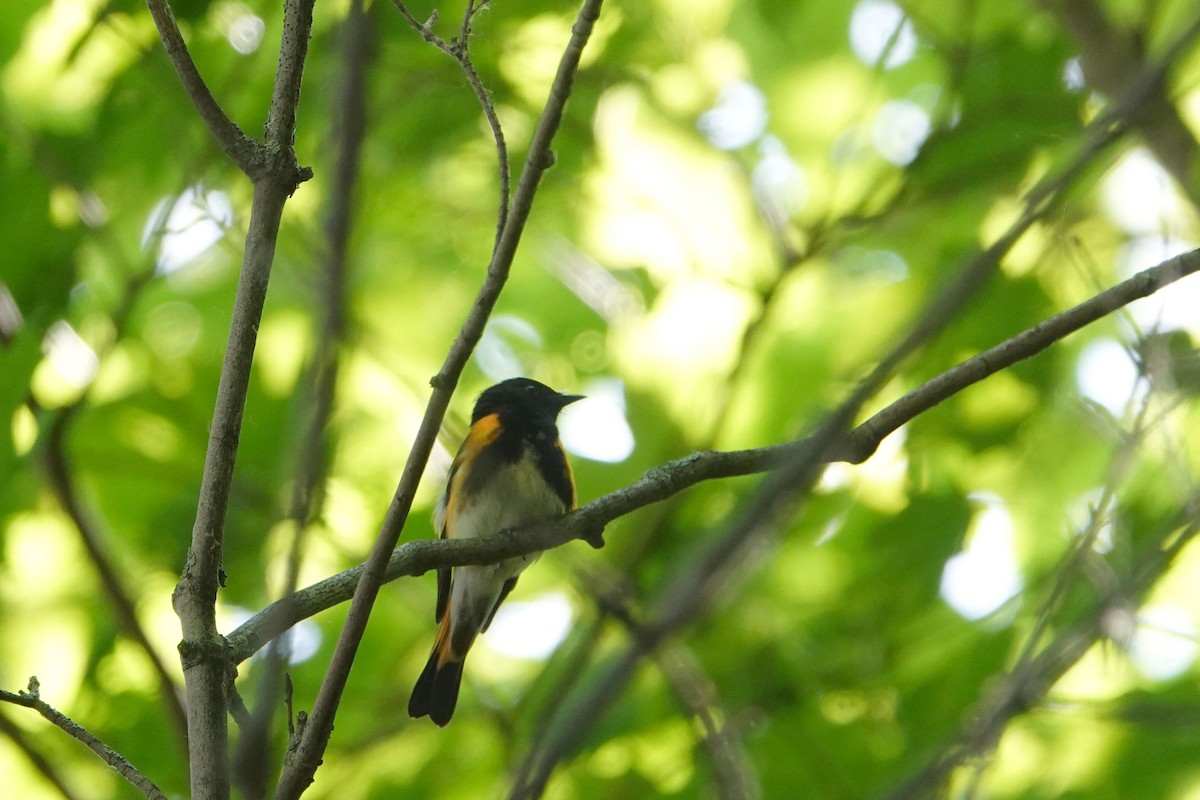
<box><xmin>408</xmin><ymin>378</ymin><xmax>583</xmax><ymax>727</ymax></box>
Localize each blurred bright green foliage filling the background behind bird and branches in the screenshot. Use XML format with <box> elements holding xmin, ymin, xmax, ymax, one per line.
<box><xmin>0</xmin><ymin>0</ymin><xmax>1200</xmax><ymax>800</ymax></box>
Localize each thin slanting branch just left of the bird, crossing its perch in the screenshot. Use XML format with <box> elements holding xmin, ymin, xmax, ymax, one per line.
<box><xmin>275</xmin><ymin>0</ymin><xmax>602</xmax><ymax>800</ymax></box>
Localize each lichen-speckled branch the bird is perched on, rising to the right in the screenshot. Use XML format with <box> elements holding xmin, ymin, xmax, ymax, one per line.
<box><xmin>228</xmin><ymin>249</ymin><xmax>1200</xmax><ymax>662</ymax></box>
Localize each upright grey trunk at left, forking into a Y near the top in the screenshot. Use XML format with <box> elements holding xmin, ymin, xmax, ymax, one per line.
<box><xmin>148</xmin><ymin>0</ymin><xmax>313</xmax><ymax>800</ymax></box>
